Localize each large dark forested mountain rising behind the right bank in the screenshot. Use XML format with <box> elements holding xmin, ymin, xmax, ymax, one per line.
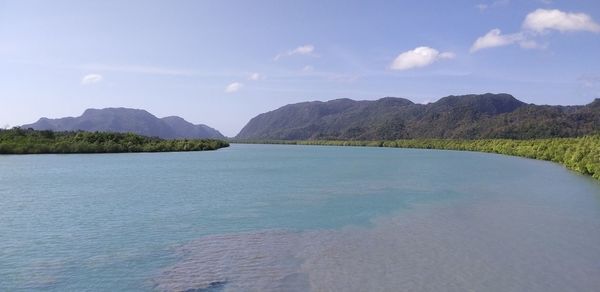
<box><xmin>236</xmin><ymin>93</ymin><xmax>600</xmax><ymax>140</ymax></box>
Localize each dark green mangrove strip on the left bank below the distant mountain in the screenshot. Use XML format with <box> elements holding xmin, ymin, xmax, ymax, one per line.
<box><xmin>0</xmin><ymin>128</ymin><xmax>229</xmax><ymax>154</ymax></box>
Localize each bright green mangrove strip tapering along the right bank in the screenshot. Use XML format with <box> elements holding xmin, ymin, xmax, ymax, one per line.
<box><xmin>238</xmin><ymin>135</ymin><xmax>600</xmax><ymax>179</ymax></box>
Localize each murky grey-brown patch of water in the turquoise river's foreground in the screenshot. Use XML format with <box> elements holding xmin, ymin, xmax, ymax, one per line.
<box><xmin>154</xmin><ymin>195</ymin><xmax>600</xmax><ymax>291</ymax></box>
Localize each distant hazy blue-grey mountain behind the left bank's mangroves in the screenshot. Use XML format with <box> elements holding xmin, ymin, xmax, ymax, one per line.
<box><xmin>21</xmin><ymin>108</ymin><xmax>225</xmax><ymax>139</ymax></box>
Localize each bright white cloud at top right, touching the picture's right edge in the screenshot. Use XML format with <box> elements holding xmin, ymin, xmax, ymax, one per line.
<box><xmin>523</xmin><ymin>9</ymin><xmax>600</xmax><ymax>33</ymax></box>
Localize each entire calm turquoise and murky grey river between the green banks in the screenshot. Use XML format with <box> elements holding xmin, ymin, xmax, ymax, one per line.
<box><xmin>0</xmin><ymin>145</ymin><xmax>600</xmax><ymax>291</ymax></box>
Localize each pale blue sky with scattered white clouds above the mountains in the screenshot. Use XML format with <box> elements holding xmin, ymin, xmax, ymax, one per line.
<box><xmin>0</xmin><ymin>0</ymin><xmax>600</xmax><ymax>136</ymax></box>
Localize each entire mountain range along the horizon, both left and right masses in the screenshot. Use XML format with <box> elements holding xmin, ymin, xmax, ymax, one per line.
<box><xmin>21</xmin><ymin>93</ymin><xmax>600</xmax><ymax>141</ymax></box>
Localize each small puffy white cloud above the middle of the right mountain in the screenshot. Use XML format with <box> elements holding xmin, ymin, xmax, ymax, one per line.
<box><xmin>390</xmin><ymin>47</ymin><xmax>455</xmax><ymax>70</ymax></box>
